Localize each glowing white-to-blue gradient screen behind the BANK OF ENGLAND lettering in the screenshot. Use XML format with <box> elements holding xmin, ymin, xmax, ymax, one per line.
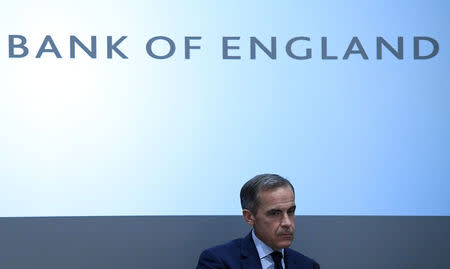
<box><xmin>0</xmin><ymin>0</ymin><xmax>450</xmax><ymax>216</ymax></box>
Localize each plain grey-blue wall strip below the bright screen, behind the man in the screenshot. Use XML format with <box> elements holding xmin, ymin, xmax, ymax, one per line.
<box><xmin>0</xmin><ymin>216</ymin><xmax>450</xmax><ymax>269</ymax></box>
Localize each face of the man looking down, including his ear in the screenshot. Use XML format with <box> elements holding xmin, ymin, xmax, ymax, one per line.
<box><xmin>244</xmin><ymin>186</ymin><xmax>295</xmax><ymax>250</ymax></box>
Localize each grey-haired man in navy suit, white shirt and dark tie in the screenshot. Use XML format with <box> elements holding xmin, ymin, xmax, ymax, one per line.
<box><xmin>197</xmin><ymin>174</ymin><xmax>320</xmax><ymax>269</ymax></box>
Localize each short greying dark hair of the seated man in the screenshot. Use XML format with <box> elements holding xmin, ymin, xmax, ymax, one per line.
<box><xmin>241</xmin><ymin>174</ymin><xmax>295</xmax><ymax>215</ymax></box>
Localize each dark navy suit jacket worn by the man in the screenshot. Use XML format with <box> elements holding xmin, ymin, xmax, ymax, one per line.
<box><xmin>197</xmin><ymin>232</ymin><xmax>320</xmax><ymax>269</ymax></box>
